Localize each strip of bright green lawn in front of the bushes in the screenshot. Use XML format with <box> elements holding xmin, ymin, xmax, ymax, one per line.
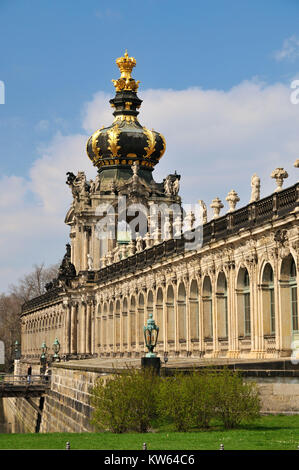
<box><xmin>0</xmin><ymin>415</ymin><xmax>299</xmax><ymax>450</ymax></box>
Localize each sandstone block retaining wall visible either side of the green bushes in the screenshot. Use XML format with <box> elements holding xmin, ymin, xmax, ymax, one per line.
<box><xmin>2</xmin><ymin>363</ymin><xmax>299</xmax><ymax>433</ymax></box>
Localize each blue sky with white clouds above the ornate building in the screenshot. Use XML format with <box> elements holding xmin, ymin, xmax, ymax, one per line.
<box><xmin>0</xmin><ymin>0</ymin><xmax>299</xmax><ymax>292</ymax></box>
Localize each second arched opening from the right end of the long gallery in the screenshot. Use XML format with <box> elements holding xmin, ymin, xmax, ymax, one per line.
<box><xmin>261</xmin><ymin>263</ymin><xmax>276</xmax><ymax>336</ymax></box>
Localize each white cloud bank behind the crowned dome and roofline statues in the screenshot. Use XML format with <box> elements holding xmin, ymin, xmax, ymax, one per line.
<box><xmin>0</xmin><ymin>81</ymin><xmax>299</xmax><ymax>291</ymax></box>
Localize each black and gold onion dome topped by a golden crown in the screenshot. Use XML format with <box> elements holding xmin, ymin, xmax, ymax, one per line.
<box><xmin>86</xmin><ymin>51</ymin><xmax>166</xmax><ymax>171</ymax></box>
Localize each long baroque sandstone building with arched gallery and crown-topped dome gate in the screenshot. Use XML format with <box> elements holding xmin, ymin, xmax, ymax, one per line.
<box><xmin>21</xmin><ymin>53</ymin><xmax>299</xmax><ymax>360</ymax></box>
